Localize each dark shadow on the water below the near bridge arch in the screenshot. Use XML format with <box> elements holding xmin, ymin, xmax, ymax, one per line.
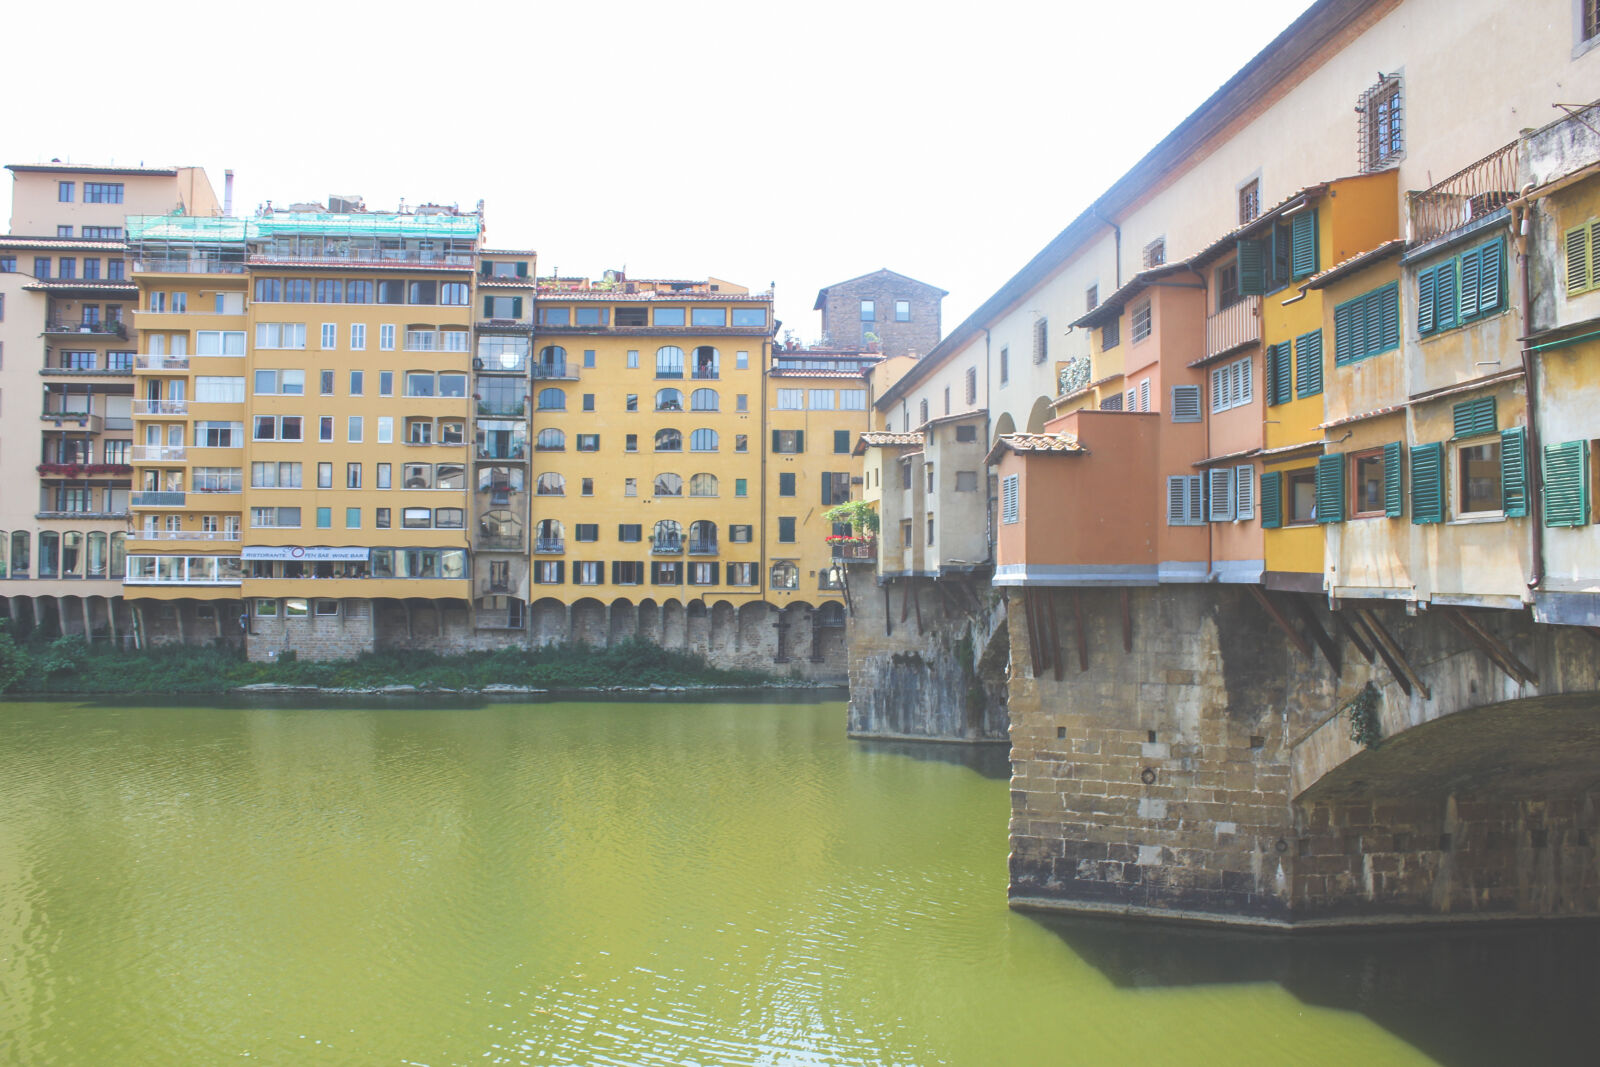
<box><xmin>1034</xmin><ymin>915</ymin><xmax>1600</xmax><ymax>1067</ymax></box>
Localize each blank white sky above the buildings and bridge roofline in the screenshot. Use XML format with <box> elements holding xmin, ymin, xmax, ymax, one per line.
<box><xmin>0</xmin><ymin>0</ymin><xmax>1307</xmax><ymax>339</ymax></box>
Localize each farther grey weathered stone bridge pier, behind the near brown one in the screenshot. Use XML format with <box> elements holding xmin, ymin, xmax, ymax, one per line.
<box><xmin>846</xmin><ymin>566</ymin><xmax>1010</xmax><ymax>741</ymax></box>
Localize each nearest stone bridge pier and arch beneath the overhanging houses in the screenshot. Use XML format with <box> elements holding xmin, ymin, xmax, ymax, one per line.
<box><xmin>1008</xmin><ymin>585</ymin><xmax>1600</xmax><ymax>926</ymax></box>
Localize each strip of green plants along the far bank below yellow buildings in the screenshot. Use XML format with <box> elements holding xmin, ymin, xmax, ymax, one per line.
<box><xmin>0</xmin><ymin>629</ymin><xmax>779</xmax><ymax>694</ymax></box>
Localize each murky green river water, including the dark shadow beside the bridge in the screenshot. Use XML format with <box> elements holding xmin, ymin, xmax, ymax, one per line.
<box><xmin>0</xmin><ymin>701</ymin><xmax>1600</xmax><ymax>1067</ymax></box>
